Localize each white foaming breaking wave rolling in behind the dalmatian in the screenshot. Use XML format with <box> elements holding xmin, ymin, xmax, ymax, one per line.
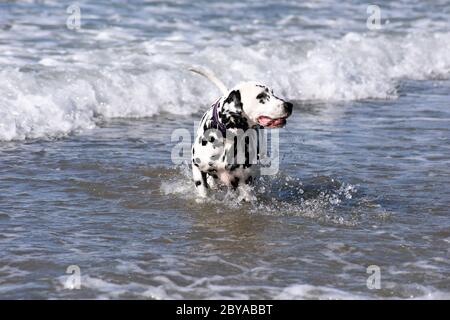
<box><xmin>0</xmin><ymin>32</ymin><xmax>450</xmax><ymax>141</ymax></box>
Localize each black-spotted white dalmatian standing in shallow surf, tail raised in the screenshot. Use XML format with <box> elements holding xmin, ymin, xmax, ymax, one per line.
<box><xmin>189</xmin><ymin>68</ymin><xmax>292</xmax><ymax>202</ymax></box>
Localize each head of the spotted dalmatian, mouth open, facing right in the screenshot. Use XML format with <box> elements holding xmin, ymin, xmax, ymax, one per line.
<box><xmin>222</xmin><ymin>81</ymin><xmax>292</xmax><ymax>129</ymax></box>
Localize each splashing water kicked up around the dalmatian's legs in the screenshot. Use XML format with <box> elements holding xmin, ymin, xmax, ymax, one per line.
<box><xmin>160</xmin><ymin>164</ymin><xmax>382</xmax><ymax>226</ymax></box>
